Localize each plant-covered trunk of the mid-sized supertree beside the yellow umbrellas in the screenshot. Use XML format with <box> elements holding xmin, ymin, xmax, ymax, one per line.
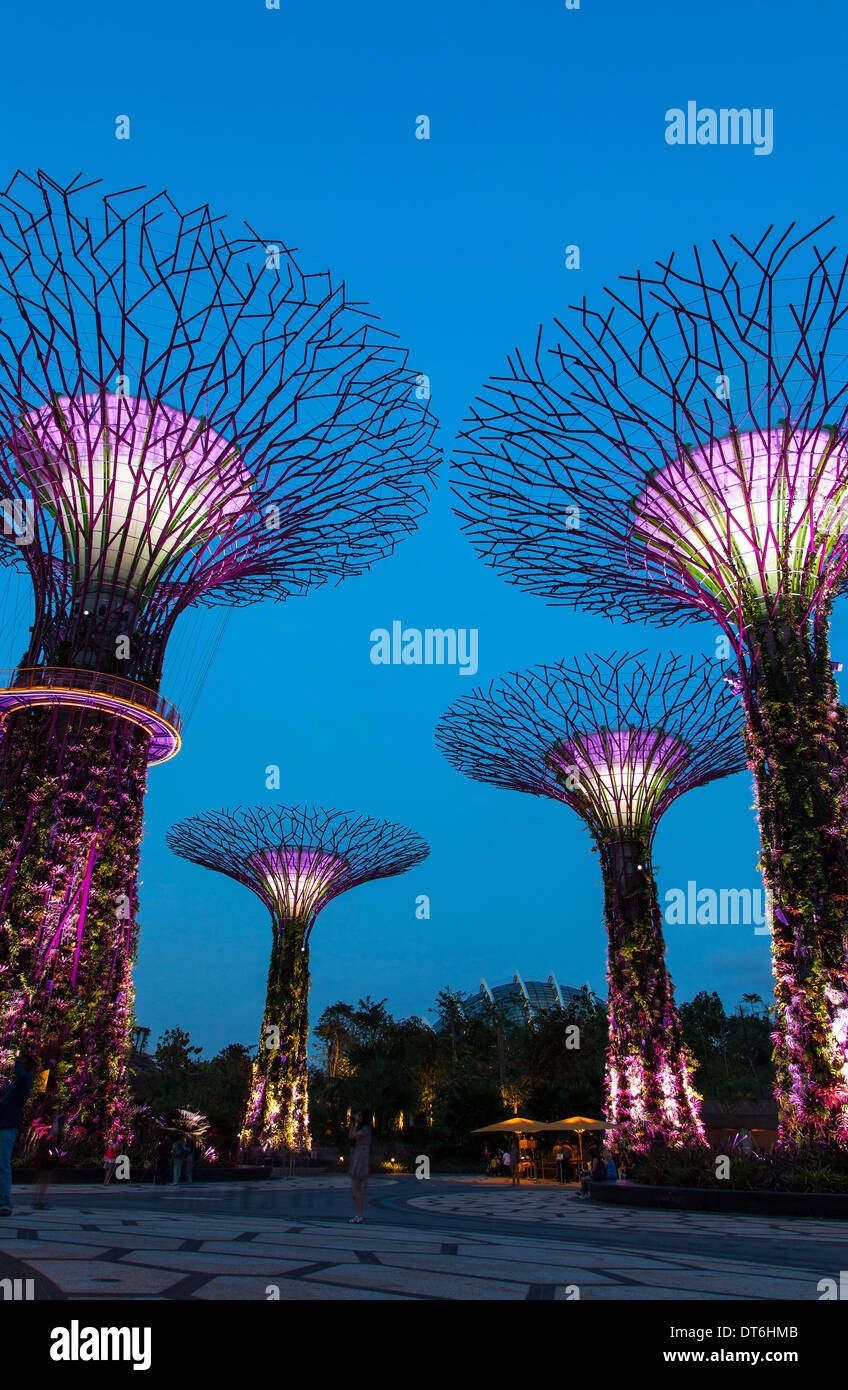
<box><xmin>599</xmin><ymin>837</ymin><xmax>705</xmax><ymax>1150</ymax></box>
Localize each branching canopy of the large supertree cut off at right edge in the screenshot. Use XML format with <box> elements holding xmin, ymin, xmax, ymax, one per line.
<box><xmin>456</xmin><ymin>224</ymin><xmax>848</xmax><ymax>628</ymax></box>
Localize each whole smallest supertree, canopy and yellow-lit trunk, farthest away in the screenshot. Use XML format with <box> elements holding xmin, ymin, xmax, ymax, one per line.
<box><xmin>168</xmin><ymin>806</ymin><xmax>430</xmax><ymax>1150</ymax></box>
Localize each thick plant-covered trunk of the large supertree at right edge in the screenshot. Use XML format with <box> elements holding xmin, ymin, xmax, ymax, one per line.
<box><xmin>747</xmin><ymin>623</ymin><xmax>848</xmax><ymax>1147</ymax></box>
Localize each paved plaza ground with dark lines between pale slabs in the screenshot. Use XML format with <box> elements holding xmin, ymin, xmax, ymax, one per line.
<box><xmin>0</xmin><ymin>1175</ymin><xmax>845</xmax><ymax>1301</ymax></box>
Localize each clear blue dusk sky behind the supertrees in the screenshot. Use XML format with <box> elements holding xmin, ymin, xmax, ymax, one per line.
<box><xmin>0</xmin><ymin>0</ymin><xmax>848</xmax><ymax>1054</ymax></box>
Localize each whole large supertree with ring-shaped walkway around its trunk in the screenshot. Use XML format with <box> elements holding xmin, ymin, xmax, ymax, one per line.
<box><xmin>0</xmin><ymin>172</ymin><xmax>435</xmax><ymax>1131</ymax></box>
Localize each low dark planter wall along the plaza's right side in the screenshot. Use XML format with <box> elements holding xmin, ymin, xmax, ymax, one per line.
<box><xmin>589</xmin><ymin>1182</ymin><xmax>848</xmax><ymax>1220</ymax></box>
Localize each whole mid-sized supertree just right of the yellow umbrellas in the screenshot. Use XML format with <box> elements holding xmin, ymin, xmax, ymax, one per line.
<box><xmin>437</xmin><ymin>653</ymin><xmax>745</xmax><ymax>1148</ymax></box>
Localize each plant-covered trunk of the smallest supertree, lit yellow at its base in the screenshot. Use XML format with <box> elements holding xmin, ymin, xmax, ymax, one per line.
<box><xmin>240</xmin><ymin>922</ymin><xmax>310</xmax><ymax>1151</ymax></box>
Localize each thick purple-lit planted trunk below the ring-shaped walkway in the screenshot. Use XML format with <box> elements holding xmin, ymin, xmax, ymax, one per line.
<box><xmin>0</xmin><ymin>708</ymin><xmax>149</xmax><ymax>1138</ymax></box>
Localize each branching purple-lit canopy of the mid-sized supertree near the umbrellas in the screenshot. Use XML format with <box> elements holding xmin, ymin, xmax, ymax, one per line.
<box><xmin>437</xmin><ymin>653</ymin><xmax>745</xmax><ymax>840</ymax></box>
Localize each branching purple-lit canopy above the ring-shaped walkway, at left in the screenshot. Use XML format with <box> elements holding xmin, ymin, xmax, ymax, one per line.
<box><xmin>0</xmin><ymin>172</ymin><xmax>435</xmax><ymax>678</ymax></box>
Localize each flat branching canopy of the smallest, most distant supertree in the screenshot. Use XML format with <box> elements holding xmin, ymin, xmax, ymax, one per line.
<box><xmin>168</xmin><ymin>806</ymin><xmax>430</xmax><ymax>922</ymax></box>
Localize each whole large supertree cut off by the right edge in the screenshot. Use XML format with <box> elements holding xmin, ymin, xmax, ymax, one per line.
<box><xmin>457</xmin><ymin>224</ymin><xmax>848</xmax><ymax>1148</ymax></box>
